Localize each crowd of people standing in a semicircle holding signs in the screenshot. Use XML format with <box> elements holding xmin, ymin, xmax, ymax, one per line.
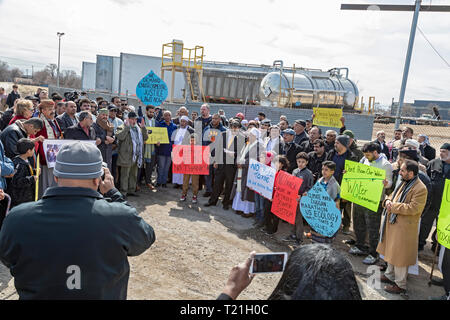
<box><xmin>0</xmin><ymin>86</ymin><xmax>450</xmax><ymax>298</ymax></box>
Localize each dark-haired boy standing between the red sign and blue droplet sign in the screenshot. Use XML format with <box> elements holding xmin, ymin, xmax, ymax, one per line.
<box><xmin>283</xmin><ymin>152</ymin><xmax>314</xmax><ymax>245</ymax></box>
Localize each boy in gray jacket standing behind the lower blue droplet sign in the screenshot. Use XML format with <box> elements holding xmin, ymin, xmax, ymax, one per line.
<box><xmin>308</xmin><ymin>161</ymin><xmax>341</xmax><ymax>243</ymax></box>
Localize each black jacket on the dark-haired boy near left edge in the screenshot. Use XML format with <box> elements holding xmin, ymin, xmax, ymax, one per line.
<box><xmin>7</xmin><ymin>156</ymin><xmax>36</xmax><ymax>207</ymax></box>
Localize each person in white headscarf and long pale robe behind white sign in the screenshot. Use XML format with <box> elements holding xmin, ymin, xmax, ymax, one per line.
<box><xmin>230</xmin><ymin>128</ymin><xmax>264</xmax><ymax>218</ymax></box>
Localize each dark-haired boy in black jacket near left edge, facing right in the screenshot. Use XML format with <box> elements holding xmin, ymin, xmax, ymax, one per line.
<box><xmin>7</xmin><ymin>138</ymin><xmax>40</xmax><ymax>208</ymax></box>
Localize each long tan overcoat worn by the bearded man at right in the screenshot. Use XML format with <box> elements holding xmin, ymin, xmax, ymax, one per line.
<box><xmin>377</xmin><ymin>179</ymin><xmax>427</xmax><ymax>267</ymax></box>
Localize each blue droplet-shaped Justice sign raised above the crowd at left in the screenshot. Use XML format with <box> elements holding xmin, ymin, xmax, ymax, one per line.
<box><xmin>136</xmin><ymin>70</ymin><xmax>169</xmax><ymax>106</ymax></box>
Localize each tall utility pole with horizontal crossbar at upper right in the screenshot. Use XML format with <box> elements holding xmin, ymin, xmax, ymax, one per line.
<box><xmin>341</xmin><ymin>0</ymin><xmax>450</xmax><ymax>129</ymax></box>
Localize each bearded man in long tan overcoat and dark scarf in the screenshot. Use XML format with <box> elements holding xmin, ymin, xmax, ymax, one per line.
<box><xmin>377</xmin><ymin>160</ymin><xmax>428</xmax><ymax>294</ymax></box>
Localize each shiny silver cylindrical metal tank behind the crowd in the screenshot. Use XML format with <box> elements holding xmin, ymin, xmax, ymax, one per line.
<box><xmin>259</xmin><ymin>61</ymin><xmax>359</xmax><ymax>109</ymax></box>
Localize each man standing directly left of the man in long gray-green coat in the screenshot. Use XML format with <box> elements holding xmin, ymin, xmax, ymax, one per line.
<box><xmin>92</xmin><ymin>108</ymin><xmax>115</xmax><ymax>170</ymax></box>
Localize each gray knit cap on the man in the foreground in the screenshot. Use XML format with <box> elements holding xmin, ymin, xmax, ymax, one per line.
<box><xmin>53</xmin><ymin>141</ymin><xmax>103</xmax><ymax>180</ymax></box>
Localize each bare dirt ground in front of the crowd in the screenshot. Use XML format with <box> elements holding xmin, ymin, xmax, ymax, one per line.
<box><xmin>0</xmin><ymin>184</ymin><xmax>443</xmax><ymax>300</ymax></box>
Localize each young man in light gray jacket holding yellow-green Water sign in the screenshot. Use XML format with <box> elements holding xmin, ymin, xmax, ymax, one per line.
<box><xmin>344</xmin><ymin>142</ymin><xmax>392</xmax><ymax>265</ymax></box>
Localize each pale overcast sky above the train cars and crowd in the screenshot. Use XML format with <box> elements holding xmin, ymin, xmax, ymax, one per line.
<box><xmin>0</xmin><ymin>0</ymin><xmax>450</xmax><ymax>105</ymax></box>
